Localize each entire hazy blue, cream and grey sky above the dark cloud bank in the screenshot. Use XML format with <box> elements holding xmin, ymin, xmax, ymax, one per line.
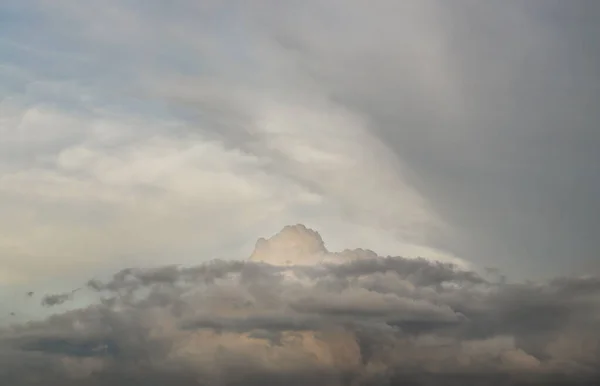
<box><xmin>0</xmin><ymin>0</ymin><xmax>600</xmax><ymax>292</ymax></box>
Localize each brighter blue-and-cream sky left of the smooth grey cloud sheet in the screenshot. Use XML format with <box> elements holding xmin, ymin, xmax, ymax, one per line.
<box><xmin>0</xmin><ymin>1</ymin><xmax>474</xmax><ymax>290</ymax></box>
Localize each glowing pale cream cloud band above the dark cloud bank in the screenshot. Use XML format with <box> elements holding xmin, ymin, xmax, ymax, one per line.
<box><xmin>0</xmin><ymin>99</ymin><xmax>450</xmax><ymax>281</ymax></box>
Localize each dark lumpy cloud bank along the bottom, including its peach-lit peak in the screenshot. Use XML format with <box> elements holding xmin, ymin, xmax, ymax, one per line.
<box><xmin>0</xmin><ymin>225</ymin><xmax>600</xmax><ymax>386</ymax></box>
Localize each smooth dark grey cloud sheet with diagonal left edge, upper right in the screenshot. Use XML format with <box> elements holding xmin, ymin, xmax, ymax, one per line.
<box><xmin>274</xmin><ymin>1</ymin><xmax>600</xmax><ymax>278</ymax></box>
